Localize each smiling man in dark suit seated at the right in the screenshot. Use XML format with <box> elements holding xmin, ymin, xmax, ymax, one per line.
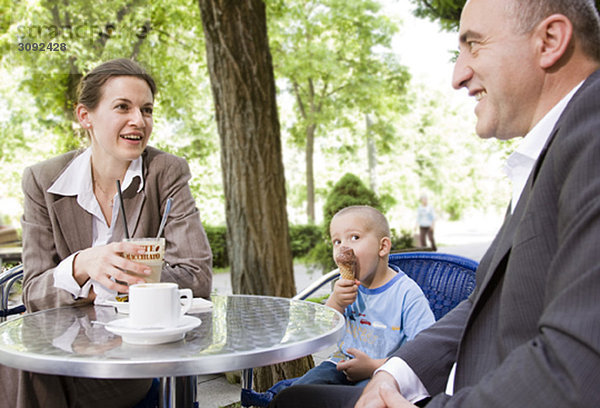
<box><xmin>273</xmin><ymin>0</ymin><xmax>600</xmax><ymax>408</ymax></box>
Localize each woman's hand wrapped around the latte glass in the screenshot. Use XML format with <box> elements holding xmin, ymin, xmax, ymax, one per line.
<box><xmin>73</xmin><ymin>242</ymin><xmax>151</xmax><ymax>293</ymax></box>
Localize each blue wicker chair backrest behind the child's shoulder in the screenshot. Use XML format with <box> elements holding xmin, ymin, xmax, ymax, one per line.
<box><xmin>389</xmin><ymin>252</ymin><xmax>478</xmax><ymax>320</ymax></box>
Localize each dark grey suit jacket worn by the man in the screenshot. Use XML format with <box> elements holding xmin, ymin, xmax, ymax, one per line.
<box><xmin>398</xmin><ymin>71</ymin><xmax>600</xmax><ymax>408</ymax></box>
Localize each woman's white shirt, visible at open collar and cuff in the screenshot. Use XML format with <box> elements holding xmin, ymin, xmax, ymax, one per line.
<box><xmin>48</xmin><ymin>148</ymin><xmax>144</xmax><ymax>303</ymax></box>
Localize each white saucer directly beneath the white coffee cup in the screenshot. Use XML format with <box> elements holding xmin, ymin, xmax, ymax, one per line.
<box><xmin>105</xmin><ymin>316</ymin><xmax>202</xmax><ymax>344</ymax></box>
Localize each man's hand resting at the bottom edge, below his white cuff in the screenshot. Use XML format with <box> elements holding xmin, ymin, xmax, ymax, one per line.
<box><xmin>354</xmin><ymin>371</ymin><xmax>415</xmax><ymax>408</ymax></box>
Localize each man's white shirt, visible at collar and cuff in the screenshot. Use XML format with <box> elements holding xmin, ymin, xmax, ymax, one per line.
<box><xmin>373</xmin><ymin>81</ymin><xmax>583</xmax><ymax>403</ymax></box>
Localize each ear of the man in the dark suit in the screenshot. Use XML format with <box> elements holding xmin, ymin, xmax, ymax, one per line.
<box><xmin>535</xmin><ymin>14</ymin><xmax>573</xmax><ymax>69</ymax></box>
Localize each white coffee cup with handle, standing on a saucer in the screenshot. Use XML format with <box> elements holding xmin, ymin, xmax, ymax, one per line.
<box><xmin>129</xmin><ymin>282</ymin><xmax>194</xmax><ymax>328</ymax></box>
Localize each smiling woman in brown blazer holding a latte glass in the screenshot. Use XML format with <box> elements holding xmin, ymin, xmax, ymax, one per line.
<box><xmin>2</xmin><ymin>59</ymin><xmax>212</xmax><ymax>407</ymax></box>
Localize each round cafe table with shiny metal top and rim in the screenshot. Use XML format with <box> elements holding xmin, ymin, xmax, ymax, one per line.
<box><xmin>0</xmin><ymin>295</ymin><xmax>344</xmax><ymax>407</ymax></box>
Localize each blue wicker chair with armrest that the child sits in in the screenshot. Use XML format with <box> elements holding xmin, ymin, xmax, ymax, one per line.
<box><xmin>241</xmin><ymin>252</ymin><xmax>478</xmax><ymax>407</ymax></box>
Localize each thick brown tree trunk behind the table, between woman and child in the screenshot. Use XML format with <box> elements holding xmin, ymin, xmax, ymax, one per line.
<box><xmin>199</xmin><ymin>0</ymin><xmax>313</xmax><ymax>391</ymax></box>
